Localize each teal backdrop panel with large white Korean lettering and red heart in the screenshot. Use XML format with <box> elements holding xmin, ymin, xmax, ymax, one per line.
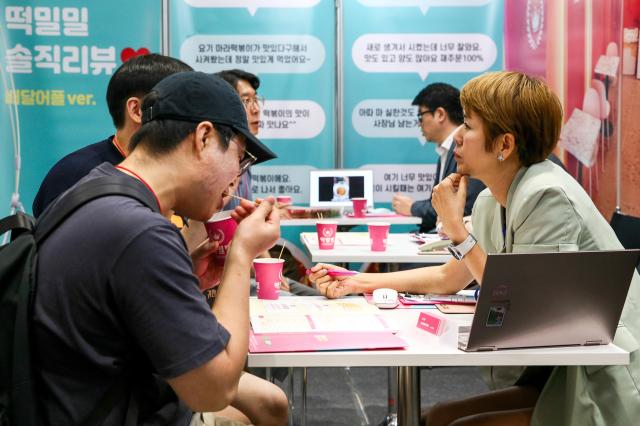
<box><xmin>0</xmin><ymin>0</ymin><xmax>161</xmax><ymax>216</ymax></box>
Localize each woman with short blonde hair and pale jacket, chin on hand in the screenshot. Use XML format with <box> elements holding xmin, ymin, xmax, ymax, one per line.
<box><xmin>311</xmin><ymin>72</ymin><xmax>640</xmax><ymax>426</ymax></box>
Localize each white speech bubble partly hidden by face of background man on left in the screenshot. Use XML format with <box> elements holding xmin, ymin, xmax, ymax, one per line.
<box><xmin>258</xmin><ymin>100</ymin><xmax>326</xmax><ymax>139</ymax></box>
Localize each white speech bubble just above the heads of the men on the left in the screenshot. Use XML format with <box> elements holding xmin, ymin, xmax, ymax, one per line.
<box><xmin>180</xmin><ymin>34</ymin><xmax>325</xmax><ymax>74</ymax></box>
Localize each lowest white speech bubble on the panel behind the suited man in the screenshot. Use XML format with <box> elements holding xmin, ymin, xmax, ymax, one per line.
<box><xmin>360</xmin><ymin>164</ymin><xmax>436</xmax><ymax>203</ymax></box>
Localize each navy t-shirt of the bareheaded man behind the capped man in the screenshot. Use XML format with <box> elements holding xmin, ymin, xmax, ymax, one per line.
<box><xmin>33</xmin><ymin>136</ymin><xmax>124</xmax><ymax>217</ymax></box>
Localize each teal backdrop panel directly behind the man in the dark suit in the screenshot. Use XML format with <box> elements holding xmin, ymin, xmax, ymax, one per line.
<box><xmin>343</xmin><ymin>0</ymin><xmax>504</xmax><ymax>203</ymax></box>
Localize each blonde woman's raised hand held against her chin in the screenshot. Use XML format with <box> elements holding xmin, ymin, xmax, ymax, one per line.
<box><xmin>431</xmin><ymin>173</ymin><xmax>469</xmax><ymax>244</ymax></box>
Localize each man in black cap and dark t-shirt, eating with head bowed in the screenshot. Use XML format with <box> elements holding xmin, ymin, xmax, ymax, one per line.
<box><xmin>33</xmin><ymin>72</ymin><xmax>279</xmax><ymax>425</ymax></box>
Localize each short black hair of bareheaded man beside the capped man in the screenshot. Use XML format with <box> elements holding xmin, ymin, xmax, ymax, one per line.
<box><xmin>107</xmin><ymin>53</ymin><xmax>193</xmax><ymax>129</ymax></box>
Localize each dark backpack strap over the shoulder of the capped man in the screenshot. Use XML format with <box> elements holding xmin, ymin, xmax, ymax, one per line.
<box><xmin>36</xmin><ymin>176</ymin><xmax>160</xmax><ymax>243</ymax></box>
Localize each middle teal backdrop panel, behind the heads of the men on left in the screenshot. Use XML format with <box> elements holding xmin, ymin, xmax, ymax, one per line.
<box><xmin>170</xmin><ymin>0</ymin><xmax>335</xmax><ymax>204</ymax></box>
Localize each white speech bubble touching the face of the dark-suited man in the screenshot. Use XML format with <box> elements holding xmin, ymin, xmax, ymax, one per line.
<box><xmin>351</xmin><ymin>99</ymin><xmax>425</xmax><ymax>145</ymax></box>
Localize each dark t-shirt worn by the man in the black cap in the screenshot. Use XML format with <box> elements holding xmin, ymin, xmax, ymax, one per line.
<box><xmin>34</xmin><ymin>163</ymin><xmax>230</xmax><ymax>425</ymax></box>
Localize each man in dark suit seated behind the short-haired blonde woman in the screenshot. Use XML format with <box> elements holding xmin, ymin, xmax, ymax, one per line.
<box><xmin>391</xmin><ymin>83</ymin><xmax>484</xmax><ymax>232</ymax></box>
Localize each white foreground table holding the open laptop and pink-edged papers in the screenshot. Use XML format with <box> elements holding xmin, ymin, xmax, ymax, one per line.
<box><xmin>248</xmin><ymin>298</ymin><xmax>629</xmax><ymax>426</ymax></box>
